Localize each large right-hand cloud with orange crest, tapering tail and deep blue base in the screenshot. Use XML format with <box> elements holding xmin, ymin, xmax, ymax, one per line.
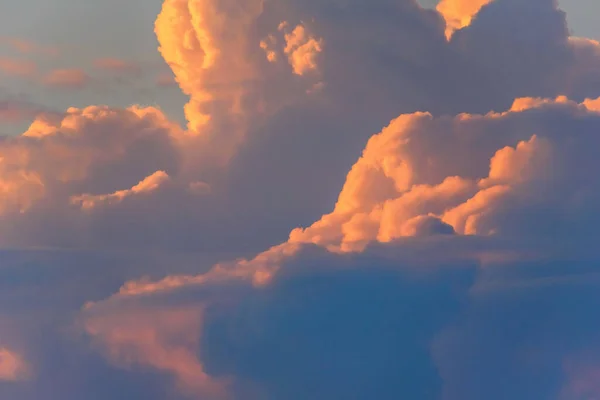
<box><xmin>79</xmin><ymin>93</ymin><xmax>600</xmax><ymax>399</ymax></box>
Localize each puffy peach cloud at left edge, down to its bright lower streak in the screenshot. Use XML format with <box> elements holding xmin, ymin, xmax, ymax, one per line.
<box><xmin>0</xmin><ymin>106</ymin><xmax>178</xmax><ymax>220</ymax></box>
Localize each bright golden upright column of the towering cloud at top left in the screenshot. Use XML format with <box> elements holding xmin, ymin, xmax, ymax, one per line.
<box><xmin>155</xmin><ymin>0</ymin><xmax>263</xmax><ymax>138</ymax></box>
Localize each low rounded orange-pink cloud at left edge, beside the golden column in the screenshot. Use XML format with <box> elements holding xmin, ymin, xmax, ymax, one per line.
<box><xmin>0</xmin><ymin>106</ymin><xmax>180</xmax><ymax>245</ymax></box>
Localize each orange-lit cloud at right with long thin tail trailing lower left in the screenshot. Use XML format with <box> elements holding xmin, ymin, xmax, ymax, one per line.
<box><xmin>99</xmin><ymin>94</ymin><xmax>600</xmax><ymax>304</ymax></box>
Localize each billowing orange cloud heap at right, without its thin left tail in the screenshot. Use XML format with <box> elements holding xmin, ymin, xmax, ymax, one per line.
<box><xmin>290</xmin><ymin>98</ymin><xmax>598</xmax><ymax>251</ymax></box>
